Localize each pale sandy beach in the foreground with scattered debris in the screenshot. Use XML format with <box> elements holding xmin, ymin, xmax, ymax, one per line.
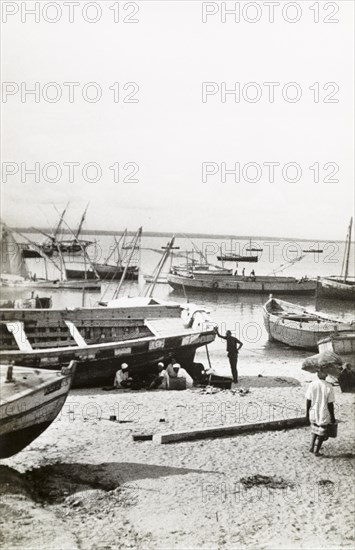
<box><xmin>0</xmin><ymin>354</ymin><xmax>355</xmax><ymax>550</ymax></box>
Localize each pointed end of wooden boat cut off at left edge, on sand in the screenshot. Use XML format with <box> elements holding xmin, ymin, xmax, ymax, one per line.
<box><xmin>0</xmin><ymin>363</ymin><xmax>75</xmax><ymax>458</ymax></box>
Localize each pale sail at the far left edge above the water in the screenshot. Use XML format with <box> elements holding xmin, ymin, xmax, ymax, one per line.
<box><xmin>0</xmin><ymin>223</ymin><xmax>28</xmax><ymax>278</ymax></box>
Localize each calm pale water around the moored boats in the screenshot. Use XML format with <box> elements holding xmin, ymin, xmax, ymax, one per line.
<box><xmin>2</xmin><ymin>235</ymin><xmax>355</xmax><ymax>380</ymax></box>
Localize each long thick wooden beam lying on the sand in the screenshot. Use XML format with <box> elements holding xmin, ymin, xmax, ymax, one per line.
<box><xmin>153</xmin><ymin>417</ymin><xmax>308</xmax><ymax>443</ymax></box>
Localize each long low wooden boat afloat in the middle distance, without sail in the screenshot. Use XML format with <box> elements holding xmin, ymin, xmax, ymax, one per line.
<box><xmin>167</xmin><ymin>272</ymin><xmax>316</xmax><ymax>294</ymax></box>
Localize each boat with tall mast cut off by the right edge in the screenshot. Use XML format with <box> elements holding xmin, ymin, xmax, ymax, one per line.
<box><xmin>317</xmin><ymin>218</ymin><xmax>355</xmax><ymax>301</ymax></box>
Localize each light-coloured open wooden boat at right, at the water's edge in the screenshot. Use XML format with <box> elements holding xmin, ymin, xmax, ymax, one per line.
<box><xmin>263</xmin><ymin>298</ymin><xmax>355</xmax><ymax>350</ymax></box>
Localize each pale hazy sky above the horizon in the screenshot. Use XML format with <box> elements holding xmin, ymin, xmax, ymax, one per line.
<box><xmin>2</xmin><ymin>0</ymin><xmax>354</xmax><ymax>239</ymax></box>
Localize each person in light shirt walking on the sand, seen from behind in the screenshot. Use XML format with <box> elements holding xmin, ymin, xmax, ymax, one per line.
<box><xmin>306</xmin><ymin>368</ymin><xmax>335</xmax><ymax>456</ymax></box>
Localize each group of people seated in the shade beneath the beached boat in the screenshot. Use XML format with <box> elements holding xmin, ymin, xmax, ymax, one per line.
<box><xmin>113</xmin><ymin>359</ymin><xmax>208</xmax><ymax>390</ymax></box>
